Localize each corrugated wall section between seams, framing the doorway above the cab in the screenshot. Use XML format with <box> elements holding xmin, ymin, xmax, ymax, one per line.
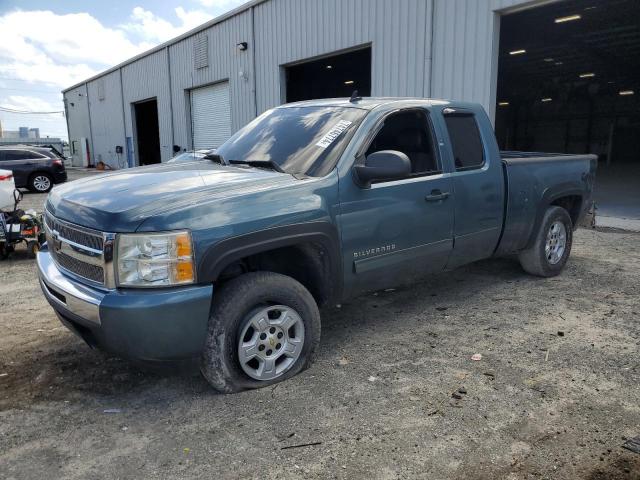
<box><xmin>255</xmin><ymin>0</ymin><xmax>432</xmax><ymax>111</ymax></box>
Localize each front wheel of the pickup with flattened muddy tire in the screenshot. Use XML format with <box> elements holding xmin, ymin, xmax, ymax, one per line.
<box><xmin>200</xmin><ymin>272</ymin><xmax>320</xmax><ymax>393</ymax></box>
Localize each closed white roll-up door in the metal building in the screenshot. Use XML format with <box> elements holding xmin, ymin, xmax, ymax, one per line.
<box><xmin>191</xmin><ymin>82</ymin><xmax>231</xmax><ymax>150</ymax></box>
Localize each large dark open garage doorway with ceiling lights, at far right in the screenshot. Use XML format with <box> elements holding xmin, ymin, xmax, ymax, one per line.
<box><xmin>496</xmin><ymin>0</ymin><xmax>640</xmax><ymax>226</ymax></box>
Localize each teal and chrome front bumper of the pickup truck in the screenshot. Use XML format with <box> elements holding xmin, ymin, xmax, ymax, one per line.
<box><xmin>37</xmin><ymin>248</ymin><xmax>213</xmax><ymax>361</ymax></box>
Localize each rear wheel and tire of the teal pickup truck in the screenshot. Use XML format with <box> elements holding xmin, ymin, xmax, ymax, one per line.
<box><xmin>518</xmin><ymin>206</ymin><xmax>573</xmax><ymax>277</ymax></box>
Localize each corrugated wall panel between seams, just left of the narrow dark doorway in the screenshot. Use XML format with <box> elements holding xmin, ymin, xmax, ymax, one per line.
<box><xmin>87</xmin><ymin>71</ymin><xmax>126</xmax><ymax>167</ymax></box>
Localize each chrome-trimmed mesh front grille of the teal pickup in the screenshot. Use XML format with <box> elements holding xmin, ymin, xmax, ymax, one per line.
<box><xmin>44</xmin><ymin>211</ymin><xmax>113</xmax><ymax>286</ymax></box>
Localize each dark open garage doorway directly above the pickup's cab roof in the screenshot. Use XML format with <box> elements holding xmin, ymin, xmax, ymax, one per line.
<box><xmin>285</xmin><ymin>47</ymin><xmax>371</xmax><ymax>102</ymax></box>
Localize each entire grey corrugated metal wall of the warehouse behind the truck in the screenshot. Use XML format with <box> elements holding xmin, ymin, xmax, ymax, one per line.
<box><xmin>65</xmin><ymin>0</ymin><xmax>545</xmax><ymax>170</ymax></box>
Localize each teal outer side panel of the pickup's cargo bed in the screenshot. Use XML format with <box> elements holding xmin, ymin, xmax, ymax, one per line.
<box><xmin>496</xmin><ymin>151</ymin><xmax>598</xmax><ymax>255</ymax></box>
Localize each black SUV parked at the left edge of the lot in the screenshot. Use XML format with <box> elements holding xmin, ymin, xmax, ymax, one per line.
<box><xmin>0</xmin><ymin>145</ymin><xmax>67</xmax><ymax>193</ymax></box>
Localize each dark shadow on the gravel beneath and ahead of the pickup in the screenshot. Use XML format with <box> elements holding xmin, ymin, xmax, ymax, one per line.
<box><xmin>0</xmin><ymin>255</ymin><xmax>584</xmax><ymax>411</ymax></box>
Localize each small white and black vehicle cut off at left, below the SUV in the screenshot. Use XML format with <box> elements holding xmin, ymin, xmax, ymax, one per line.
<box><xmin>0</xmin><ymin>170</ymin><xmax>45</xmax><ymax>260</ymax></box>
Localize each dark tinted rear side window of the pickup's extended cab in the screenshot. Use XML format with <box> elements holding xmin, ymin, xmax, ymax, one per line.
<box><xmin>444</xmin><ymin>114</ymin><xmax>484</xmax><ymax>171</ymax></box>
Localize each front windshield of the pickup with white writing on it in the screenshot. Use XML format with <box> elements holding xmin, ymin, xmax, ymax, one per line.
<box><xmin>217</xmin><ymin>107</ymin><xmax>367</xmax><ymax>177</ymax></box>
